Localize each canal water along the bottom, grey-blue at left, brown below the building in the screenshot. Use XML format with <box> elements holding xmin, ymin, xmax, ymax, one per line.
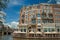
<box><xmin>0</xmin><ymin>35</ymin><xmax>60</xmax><ymax>40</ymax></box>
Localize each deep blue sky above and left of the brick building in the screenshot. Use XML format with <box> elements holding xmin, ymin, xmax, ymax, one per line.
<box><xmin>4</xmin><ymin>0</ymin><xmax>60</xmax><ymax>23</ymax></box>
